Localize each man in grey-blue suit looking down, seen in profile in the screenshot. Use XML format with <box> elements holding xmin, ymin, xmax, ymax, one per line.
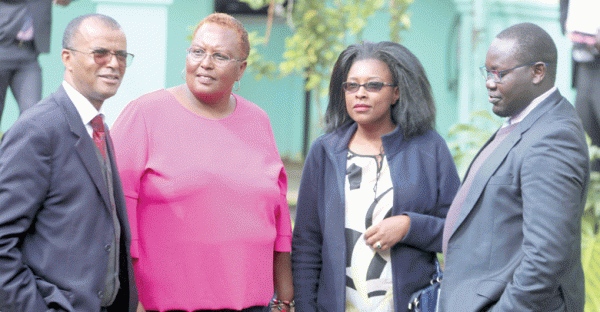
<box><xmin>440</xmin><ymin>23</ymin><xmax>589</xmax><ymax>312</ymax></box>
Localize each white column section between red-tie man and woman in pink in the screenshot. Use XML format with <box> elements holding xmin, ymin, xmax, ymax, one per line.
<box><xmin>92</xmin><ymin>0</ymin><xmax>173</xmax><ymax>126</ymax></box>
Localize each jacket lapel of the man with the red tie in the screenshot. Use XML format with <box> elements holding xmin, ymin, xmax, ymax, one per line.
<box><xmin>54</xmin><ymin>86</ymin><xmax>110</xmax><ymax>209</ymax></box>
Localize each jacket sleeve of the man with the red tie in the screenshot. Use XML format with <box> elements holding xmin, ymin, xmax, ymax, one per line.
<box><xmin>0</xmin><ymin>121</ymin><xmax>57</xmax><ymax>311</ymax></box>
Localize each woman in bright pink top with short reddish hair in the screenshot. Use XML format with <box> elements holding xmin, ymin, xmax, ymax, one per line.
<box><xmin>112</xmin><ymin>13</ymin><xmax>293</xmax><ymax>312</ymax></box>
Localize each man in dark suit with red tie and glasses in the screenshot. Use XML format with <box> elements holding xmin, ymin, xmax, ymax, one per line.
<box><xmin>0</xmin><ymin>14</ymin><xmax>138</xmax><ymax>312</ymax></box>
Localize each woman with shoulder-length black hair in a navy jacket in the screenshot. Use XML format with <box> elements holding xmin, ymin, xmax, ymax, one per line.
<box><xmin>292</xmin><ymin>42</ymin><xmax>460</xmax><ymax>312</ymax></box>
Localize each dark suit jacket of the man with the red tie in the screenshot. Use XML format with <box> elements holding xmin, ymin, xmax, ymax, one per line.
<box><xmin>0</xmin><ymin>86</ymin><xmax>138</xmax><ymax>312</ymax></box>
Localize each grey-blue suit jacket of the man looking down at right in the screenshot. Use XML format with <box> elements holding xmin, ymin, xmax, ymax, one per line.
<box><xmin>440</xmin><ymin>91</ymin><xmax>589</xmax><ymax>312</ymax></box>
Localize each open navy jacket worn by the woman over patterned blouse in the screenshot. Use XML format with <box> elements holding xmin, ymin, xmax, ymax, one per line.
<box><xmin>292</xmin><ymin>124</ymin><xmax>460</xmax><ymax>312</ymax></box>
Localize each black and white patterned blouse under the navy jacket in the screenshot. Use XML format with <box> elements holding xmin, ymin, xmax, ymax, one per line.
<box><xmin>345</xmin><ymin>151</ymin><xmax>394</xmax><ymax>312</ymax></box>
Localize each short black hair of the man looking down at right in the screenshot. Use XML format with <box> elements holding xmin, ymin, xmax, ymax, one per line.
<box><xmin>496</xmin><ymin>23</ymin><xmax>558</xmax><ymax>83</ymax></box>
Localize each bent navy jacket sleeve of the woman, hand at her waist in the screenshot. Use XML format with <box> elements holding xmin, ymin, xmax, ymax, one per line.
<box><xmin>400</xmin><ymin>135</ymin><xmax>460</xmax><ymax>252</ymax></box>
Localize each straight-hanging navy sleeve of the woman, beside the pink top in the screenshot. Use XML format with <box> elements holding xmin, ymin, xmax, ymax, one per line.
<box><xmin>292</xmin><ymin>141</ymin><xmax>324</xmax><ymax>312</ymax></box>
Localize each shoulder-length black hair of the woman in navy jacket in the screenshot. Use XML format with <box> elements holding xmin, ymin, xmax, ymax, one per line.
<box><xmin>325</xmin><ymin>41</ymin><xmax>435</xmax><ymax>139</ymax></box>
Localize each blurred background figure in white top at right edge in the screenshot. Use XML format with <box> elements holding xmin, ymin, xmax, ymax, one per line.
<box><xmin>560</xmin><ymin>0</ymin><xmax>600</xmax><ymax>171</ymax></box>
